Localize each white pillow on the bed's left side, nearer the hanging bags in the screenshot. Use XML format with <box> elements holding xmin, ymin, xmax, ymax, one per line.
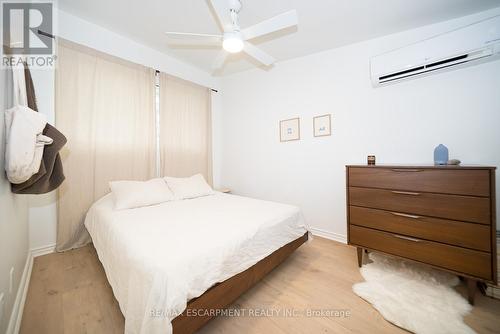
<box><xmin>109</xmin><ymin>178</ymin><xmax>174</xmax><ymax>210</ymax></box>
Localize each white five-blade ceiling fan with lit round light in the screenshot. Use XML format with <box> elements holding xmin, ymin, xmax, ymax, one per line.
<box><xmin>166</xmin><ymin>0</ymin><xmax>297</xmax><ymax>70</ymax></box>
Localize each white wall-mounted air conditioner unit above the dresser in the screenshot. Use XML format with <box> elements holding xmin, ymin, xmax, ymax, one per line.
<box><xmin>370</xmin><ymin>15</ymin><xmax>500</xmax><ymax>87</ymax></box>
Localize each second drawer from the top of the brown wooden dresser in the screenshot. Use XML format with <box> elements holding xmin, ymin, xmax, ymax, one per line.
<box><xmin>349</xmin><ymin>187</ymin><xmax>490</xmax><ymax>225</ymax></box>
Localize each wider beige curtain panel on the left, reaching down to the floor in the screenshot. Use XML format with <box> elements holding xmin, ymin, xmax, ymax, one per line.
<box><xmin>56</xmin><ymin>41</ymin><xmax>155</xmax><ymax>251</ymax></box>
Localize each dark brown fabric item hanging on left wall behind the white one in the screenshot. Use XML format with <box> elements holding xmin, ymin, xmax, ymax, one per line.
<box><xmin>11</xmin><ymin>64</ymin><xmax>67</xmax><ymax>195</ymax></box>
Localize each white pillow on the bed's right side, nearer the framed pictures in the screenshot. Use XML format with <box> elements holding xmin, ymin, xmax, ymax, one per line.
<box><xmin>165</xmin><ymin>174</ymin><xmax>214</xmax><ymax>199</ymax></box>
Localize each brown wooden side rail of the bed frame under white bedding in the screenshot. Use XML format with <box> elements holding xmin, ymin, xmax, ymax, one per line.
<box><xmin>172</xmin><ymin>232</ymin><xmax>307</xmax><ymax>334</ymax></box>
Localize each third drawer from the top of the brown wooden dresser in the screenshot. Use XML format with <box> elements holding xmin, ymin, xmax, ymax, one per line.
<box><xmin>349</xmin><ymin>206</ymin><xmax>491</xmax><ymax>252</ymax></box>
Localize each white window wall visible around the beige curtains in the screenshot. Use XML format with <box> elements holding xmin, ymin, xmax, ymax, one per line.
<box><xmin>28</xmin><ymin>11</ymin><xmax>220</xmax><ymax>249</ymax></box>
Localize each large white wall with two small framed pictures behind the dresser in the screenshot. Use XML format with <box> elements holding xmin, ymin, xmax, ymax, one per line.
<box><xmin>218</xmin><ymin>8</ymin><xmax>500</xmax><ymax>240</ymax></box>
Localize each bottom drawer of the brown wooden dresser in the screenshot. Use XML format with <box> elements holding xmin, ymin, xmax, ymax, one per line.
<box><xmin>349</xmin><ymin>225</ymin><xmax>492</xmax><ymax>280</ymax></box>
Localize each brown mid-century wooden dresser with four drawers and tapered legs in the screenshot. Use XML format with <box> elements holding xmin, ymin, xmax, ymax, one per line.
<box><xmin>346</xmin><ymin>165</ymin><xmax>497</xmax><ymax>304</ymax></box>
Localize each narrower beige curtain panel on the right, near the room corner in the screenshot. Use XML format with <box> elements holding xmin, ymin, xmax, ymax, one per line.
<box><xmin>160</xmin><ymin>73</ymin><xmax>212</xmax><ymax>184</ymax></box>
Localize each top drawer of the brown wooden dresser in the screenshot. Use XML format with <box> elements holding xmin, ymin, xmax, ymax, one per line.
<box><xmin>349</xmin><ymin>167</ymin><xmax>490</xmax><ymax>196</ymax></box>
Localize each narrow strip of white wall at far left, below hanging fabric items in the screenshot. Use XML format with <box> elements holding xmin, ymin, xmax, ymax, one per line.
<box><xmin>0</xmin><ymin>70</ymin><xmax>29</xmax><ymax>333</ymax></box>
